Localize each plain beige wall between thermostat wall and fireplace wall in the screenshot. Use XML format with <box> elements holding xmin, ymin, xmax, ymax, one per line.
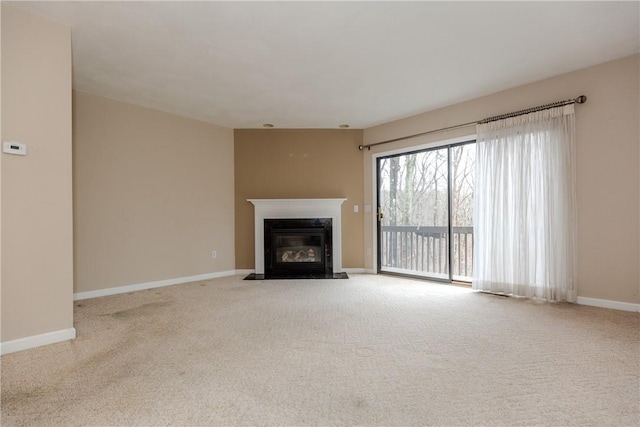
<box><xmin>73</xmin><ymin>91</ymin><xmax>235</xmax><ymax>292</ymax></box>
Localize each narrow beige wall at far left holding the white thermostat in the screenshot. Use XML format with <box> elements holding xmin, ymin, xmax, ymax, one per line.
<box><xmin>1</xmin><ymin>3</ymin><xmax>73</xmax><ymax>342</ymax></box>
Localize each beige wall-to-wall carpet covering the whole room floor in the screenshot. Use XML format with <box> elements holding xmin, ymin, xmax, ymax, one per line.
<box><xmin>1</xmin><ymin>275</ymin><xmax>640</xmax><ymax>426</ymax></box>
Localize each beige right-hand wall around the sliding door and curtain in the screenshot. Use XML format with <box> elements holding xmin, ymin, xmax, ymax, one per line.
<box><xmin>364</xmin><ymin>55</ymin><xmax>640</xmax><ymax>304</ymax></box>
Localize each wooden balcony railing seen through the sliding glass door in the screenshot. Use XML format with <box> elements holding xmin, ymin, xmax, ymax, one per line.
<box><xmin>380</xmin><ymin>225</ymin><xmax>473</xmax><ymax>280</ymax></box>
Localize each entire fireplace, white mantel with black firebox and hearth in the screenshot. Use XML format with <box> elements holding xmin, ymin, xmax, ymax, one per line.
<box><xmin>246</xmin><ymin>199</ymin><xmax>348</xmax><ymax>280</ymax></box>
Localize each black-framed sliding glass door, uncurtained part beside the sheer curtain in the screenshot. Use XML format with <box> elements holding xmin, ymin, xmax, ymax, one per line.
<box><xmin>377</xmin><ymin>141</ymin><xmax>475</xmax><ymax>281</ymax></box>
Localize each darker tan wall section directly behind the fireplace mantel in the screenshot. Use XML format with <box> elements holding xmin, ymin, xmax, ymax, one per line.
<box><xmin>235</xmin><ymin>129</ymin><xmax>364</xmax><ymax>269</ymax></box>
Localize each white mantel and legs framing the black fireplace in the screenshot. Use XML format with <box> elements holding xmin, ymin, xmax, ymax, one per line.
<box><xmin>247</xmin><ymin>199</ymin><xmax>347</xmax><ymax>274</ymax></box>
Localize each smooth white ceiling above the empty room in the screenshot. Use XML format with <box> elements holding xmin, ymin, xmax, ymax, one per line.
<box><xmin>14</xmin><ymin>1</ymin><xmax>640</xmax><ymax>128</ymax></box>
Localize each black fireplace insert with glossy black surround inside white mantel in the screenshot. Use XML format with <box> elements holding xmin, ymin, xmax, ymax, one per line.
<box><xmin>264</xmin><ymin>218</ymin><xmax>333</xmax><ymax>278</ymax></box>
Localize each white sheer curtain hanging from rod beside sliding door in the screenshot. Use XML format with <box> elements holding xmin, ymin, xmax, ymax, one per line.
<box><xmin>473</xmin><ymin>105</ymin><xmax>577</xmax><ymax>302</ymax></box>
